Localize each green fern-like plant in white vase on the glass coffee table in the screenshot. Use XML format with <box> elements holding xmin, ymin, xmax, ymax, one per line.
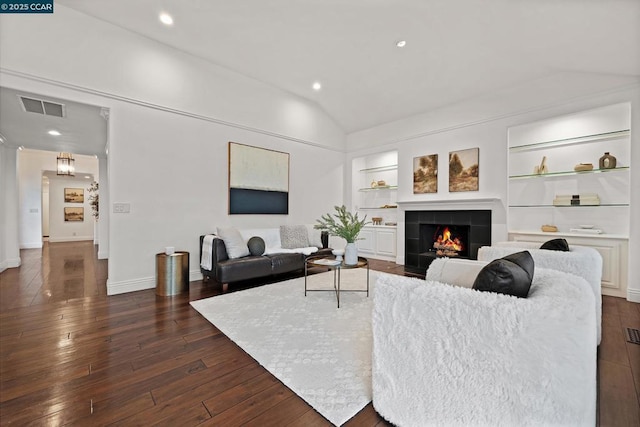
<box><xmin>314</xmin><ymin>205</ymin><xmax>368</xmax><ymax>265</ymax></box>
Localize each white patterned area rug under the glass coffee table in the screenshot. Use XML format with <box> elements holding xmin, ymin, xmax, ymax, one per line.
<box><xmin>191</xmin><ymin>269</ymin><xmax>385</xmax><ymax>425</ymax></box>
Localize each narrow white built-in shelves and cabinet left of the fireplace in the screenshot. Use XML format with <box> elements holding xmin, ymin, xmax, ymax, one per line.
<box><xmin>352</xmin><ymin>151</ymin><xmax>398</xmax><ymax>261</ymax></box>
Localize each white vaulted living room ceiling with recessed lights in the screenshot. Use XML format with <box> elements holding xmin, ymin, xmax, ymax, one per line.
<box><xmin>57</xmin><ymin>0</ymin><xmax>640</xmax><ymax>132</ymax></box>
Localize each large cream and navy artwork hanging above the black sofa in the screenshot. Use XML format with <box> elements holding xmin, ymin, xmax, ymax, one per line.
<box><xmin>229</xmin><ymin>142</ymin><xmax>289</xmax><ymax>215</ymax></box>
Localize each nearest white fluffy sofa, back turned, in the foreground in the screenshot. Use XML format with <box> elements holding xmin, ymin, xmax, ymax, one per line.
<box><xmin>372</xmin><ymin>259</ymin><xmax>597</xmax><ymax>426</ymax></box>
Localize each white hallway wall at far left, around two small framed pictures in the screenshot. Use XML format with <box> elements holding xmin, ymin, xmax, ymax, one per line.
<box><xmin>17</xmin><ymin>149</ymin><xmax>98</xmax><ymax>249</ymax></box>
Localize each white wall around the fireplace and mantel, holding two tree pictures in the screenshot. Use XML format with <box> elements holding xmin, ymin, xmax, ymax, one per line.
<box><xmin>345</xmin><ymin>84</ymin><xmax>640</xmax><ymax>302</ymax></box>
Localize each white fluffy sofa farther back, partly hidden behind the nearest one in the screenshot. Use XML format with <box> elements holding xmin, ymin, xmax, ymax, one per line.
<box><xmin>478</xmin><ymin>242</ymin><xmax>602</xmax><ymax>345</ymax></box>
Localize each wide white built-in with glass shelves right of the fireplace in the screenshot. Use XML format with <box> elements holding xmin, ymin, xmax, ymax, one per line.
<box><xmin>508</xmin><ymin>103</ymin><xmax>631</xmax><ymax>298</ymax></box>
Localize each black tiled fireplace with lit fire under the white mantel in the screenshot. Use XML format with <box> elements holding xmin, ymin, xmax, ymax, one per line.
<box><xmin>404</xmin><ymin>210</ymin><xmax>491</xmax><ymax>274</ymax></box>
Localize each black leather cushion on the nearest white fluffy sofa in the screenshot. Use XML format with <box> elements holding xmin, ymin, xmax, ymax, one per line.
<box><xmin>473</xmin><ymin>251</ymin><xmax>534</xmax><ymax>298</ymax></box>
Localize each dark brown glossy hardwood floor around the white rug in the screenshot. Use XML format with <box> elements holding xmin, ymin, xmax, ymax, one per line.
<box><xmin>0</xmin><ymin>242</ymin><xmax>640</xmax><ymax>426</ymax></box>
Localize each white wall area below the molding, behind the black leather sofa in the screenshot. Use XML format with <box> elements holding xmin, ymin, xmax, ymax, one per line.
<box><xmin>108</xmin><ymin>103</ymin><xmax>344</xmax><ymax>293</ymax></box>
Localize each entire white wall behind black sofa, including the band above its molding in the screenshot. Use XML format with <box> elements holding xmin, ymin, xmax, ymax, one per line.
<box><xmin>0</xmin><ymin>5</ymin><xmax>345</xmax><ymax>294</ymax></box>
